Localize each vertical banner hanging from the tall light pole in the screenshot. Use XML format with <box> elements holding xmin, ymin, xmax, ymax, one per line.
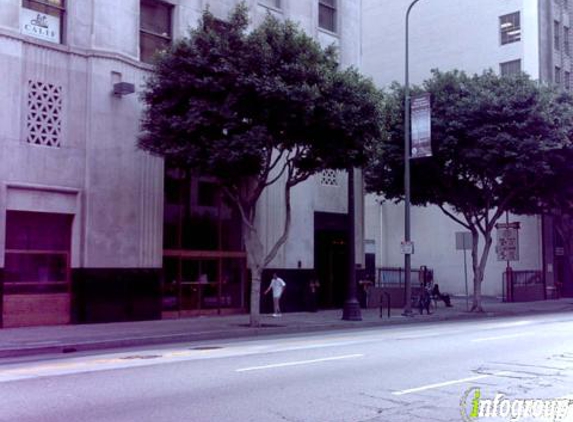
<box><xmin>411</xmin><ymin>94</ymin><xmax>432</xmax><ymax>158</ymax></box>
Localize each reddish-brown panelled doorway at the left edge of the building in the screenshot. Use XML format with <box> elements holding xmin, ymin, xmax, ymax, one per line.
<box><xmin>2</xmin><ymin>211</ymin><xmax>73</xmax><ymax>327</ymax></box>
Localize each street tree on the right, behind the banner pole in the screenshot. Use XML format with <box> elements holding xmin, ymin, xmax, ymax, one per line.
<box><xmin>365</xmin><ymin>70</ymin><xmax>572</xmax><ymax>312</ymax></box>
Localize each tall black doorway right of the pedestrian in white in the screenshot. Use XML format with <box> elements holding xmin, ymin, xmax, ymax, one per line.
<box><xmin>314</xmin><ymin>212</ymin><xmax>348</xmax><ymax>308</ymax></box>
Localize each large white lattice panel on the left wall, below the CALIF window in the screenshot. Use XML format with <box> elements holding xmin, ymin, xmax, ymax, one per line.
<box><xmin>26</xmin><ymin>81</ymin><xmax>62</xmax><ymax>147</ymax></box>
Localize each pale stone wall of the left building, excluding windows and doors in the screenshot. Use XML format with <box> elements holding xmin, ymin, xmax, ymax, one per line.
<box><xmin>0</xmin><ymin>0</ymin><xmax>363</xmax><ymax>322</ymax></box>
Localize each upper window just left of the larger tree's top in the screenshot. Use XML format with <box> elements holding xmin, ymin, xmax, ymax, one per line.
<box><xmin>139</xmin><ymin>0</ymin><xmax>173</xmax><ymax>63</ymax></box>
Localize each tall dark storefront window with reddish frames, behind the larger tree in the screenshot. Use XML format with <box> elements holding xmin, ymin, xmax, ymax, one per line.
<box><xmin>163</xmin><ymin>168</ymin><xmax>246</xmax><ymax>315</ymax></box>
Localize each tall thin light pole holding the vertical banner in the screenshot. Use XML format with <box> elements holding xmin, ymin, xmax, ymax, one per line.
<box><xmin>402</xmin><ymin>0</ymin><xmax>420</xmax><ymax>316</ymax></box>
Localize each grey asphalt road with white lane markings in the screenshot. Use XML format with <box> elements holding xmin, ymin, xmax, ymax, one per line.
<box><xmin>0</xmin><ymin>314</ymin><xmax>573</xmax><ymax>422</ymax></box>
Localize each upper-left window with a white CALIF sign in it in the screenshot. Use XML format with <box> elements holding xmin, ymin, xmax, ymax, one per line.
<box><xmin>20</xmin><ymin>0</ymin><xmax>66</xmax><ymax>44</ymax></box>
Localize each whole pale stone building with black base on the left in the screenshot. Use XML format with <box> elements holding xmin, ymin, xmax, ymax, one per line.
<box><xmin>0</xmin><ymin>0</ymin><xmax>363</xmax><ymax>327</ymax></box>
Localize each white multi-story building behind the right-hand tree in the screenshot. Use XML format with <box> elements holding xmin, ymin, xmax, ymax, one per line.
<box><xmin>362</xmin><ymin>0</ymin><xmax>573</xmax><ymax>298</ymax></box>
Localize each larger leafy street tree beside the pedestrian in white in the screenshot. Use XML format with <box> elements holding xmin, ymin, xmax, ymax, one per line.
<box><xmin>139</xmin><ymin>4</ymin><xmax>380</xmax><ymax>326</ymax></box>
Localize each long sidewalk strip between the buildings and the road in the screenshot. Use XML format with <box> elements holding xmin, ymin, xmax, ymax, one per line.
<box><xmin>0</xmin><ymin>297</ymin><xmax>573</xmax><ymax>358</ymax></box>
